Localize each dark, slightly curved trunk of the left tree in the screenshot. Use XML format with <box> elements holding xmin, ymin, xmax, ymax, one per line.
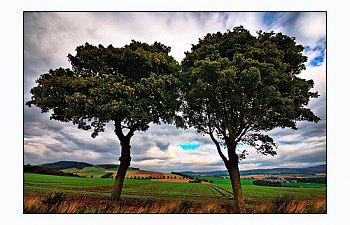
<box><xmin>111</xmin><ymin>139</ymin><xmax>131</xmax><ymax>203</ymax></box>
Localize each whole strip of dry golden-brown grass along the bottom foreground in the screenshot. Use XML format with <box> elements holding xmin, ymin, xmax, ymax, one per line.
<box><xmin>24</xmin><ymin>193</ymin><xmax>326</xmax><ymax>213</ymax></box>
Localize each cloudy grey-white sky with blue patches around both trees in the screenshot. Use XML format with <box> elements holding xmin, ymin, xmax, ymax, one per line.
<box><xmin>23</xmin><ymin>12</ymin><xmax>326</xmax><ymax>171</ymax></box>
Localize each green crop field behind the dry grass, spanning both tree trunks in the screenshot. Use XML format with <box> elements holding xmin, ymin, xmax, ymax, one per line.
<box><xmin>24</xmin><ymin>173</ymin><xmax>326</xmax><ymax>211</ymax></box>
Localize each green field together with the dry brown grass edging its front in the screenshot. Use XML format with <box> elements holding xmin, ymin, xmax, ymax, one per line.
<box><xmin>24</xmin><ymin>173</ymin><xmax>326</xmax><ymax>213</ymax></box>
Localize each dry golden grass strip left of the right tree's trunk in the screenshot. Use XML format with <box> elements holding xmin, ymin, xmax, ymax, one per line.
<box><xmin>24</xmin><ymin>192</ymin><xmax>234</xmax><ymax>214</ymax></box>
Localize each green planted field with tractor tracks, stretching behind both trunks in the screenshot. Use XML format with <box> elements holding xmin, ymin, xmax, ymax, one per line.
<box><xmin>24</xmin><ymin>173</ymin><xmax>326</xmax><ymax>203</ymax></box>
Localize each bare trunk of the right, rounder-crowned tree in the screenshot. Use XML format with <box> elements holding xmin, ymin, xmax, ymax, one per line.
<box><xmin>225</xmin><ymin>144</ymin><xmax>245</xmax><ymax>213</ymax></box>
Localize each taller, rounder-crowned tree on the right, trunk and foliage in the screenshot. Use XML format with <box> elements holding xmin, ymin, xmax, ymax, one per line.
<box><xmin>181</xmin><ymin>26</ymin><xmax>319</xmax><ymax>212</ymax></box>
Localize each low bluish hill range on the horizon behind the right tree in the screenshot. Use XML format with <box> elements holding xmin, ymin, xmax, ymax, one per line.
<box><xmin>179</xmin><ymin>164</ymin><xmax>327</xmax><ymax>176</ymax></box>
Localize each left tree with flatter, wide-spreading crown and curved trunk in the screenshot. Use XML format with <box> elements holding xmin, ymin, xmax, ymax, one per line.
<box><xmin>26</xmin><ymin>41</ymin><xmax>180</xmax><ymax>202</ymax></box>
